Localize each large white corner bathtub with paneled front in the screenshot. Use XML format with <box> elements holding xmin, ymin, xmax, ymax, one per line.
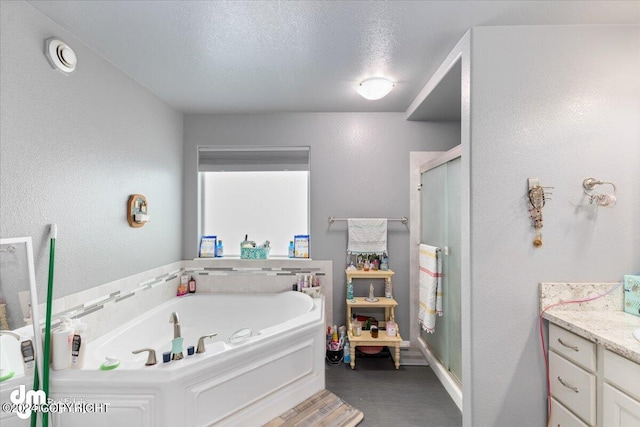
<box><xmin>49</xmin><ymin>292</ymin><xmax>325</xmax><ymax>427</ymax></box>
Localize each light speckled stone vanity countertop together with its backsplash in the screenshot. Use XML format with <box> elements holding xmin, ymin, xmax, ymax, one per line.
<box><xmin>540</xmin><ymin>283</ymin><xmax>640</xmax><ymax>363</ymax></box>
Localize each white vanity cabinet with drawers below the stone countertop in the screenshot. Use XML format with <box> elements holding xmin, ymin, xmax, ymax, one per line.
<box><xmin>549</xmin><ymin>324</ymin><xmax>640</xmax><ymax>427</ymax></box>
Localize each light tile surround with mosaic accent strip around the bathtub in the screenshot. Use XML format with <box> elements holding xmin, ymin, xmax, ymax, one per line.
<box><xmin>38</xmin><ymin>258</ymin><xmax>333</xmax><ymax>341</ymax></box>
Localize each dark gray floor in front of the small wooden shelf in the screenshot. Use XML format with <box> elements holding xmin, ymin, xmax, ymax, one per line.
<box><xmin>325</xmin><ymin>356</ymin><xmax>462</xmax><ymax>427</ymax></box>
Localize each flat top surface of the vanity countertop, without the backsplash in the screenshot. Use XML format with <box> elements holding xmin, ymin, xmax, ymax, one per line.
<box><xmin>542</xmin><ymin>309</ymin><xmax>640</xmax><ymax>363</ymax></box>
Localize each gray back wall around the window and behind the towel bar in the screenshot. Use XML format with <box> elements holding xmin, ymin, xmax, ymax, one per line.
<box><xmin>183</xmin><ymin>113</ymin><xmax>460</xmax><ymax>340</ymax></box>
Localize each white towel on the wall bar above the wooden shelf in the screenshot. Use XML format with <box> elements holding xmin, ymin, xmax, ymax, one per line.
<box><xmin>347</xmin><ymin>218</ymin><xmax>387</xmax><ymax>255</ymax></box>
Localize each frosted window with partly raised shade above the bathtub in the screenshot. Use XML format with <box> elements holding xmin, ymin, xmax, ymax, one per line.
<box><xmin>198</xmin><ymin>147</ymin><xmax>309</xmax><ymax>256</ymax></box>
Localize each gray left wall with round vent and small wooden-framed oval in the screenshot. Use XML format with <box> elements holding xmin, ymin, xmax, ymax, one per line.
<box><xmin>0</xmin><ymin>1</ymin><xmax>182</xmax><ymax>301</ymax></box>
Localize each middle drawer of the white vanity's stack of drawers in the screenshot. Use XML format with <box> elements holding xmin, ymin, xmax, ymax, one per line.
<box><xmin>549</xmin><ymin>351</ymin><xmax>596</xmax><ymax>425</ymax></box>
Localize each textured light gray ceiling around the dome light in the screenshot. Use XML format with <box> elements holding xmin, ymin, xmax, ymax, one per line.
<box><xmin>29</xmin><ymin>0</ymin><xmax>640</xmax><ymax>113</ymax></box>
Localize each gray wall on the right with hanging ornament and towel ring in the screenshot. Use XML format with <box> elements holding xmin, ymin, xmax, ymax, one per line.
<box><xmin>463</xmin><ymin>26</ymin><xmax>640</xmax><ymax>426</ymax></box>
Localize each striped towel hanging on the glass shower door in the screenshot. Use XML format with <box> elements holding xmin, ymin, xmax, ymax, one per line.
<box><xmin>418</xmin><ymin>243</ymin><xmax>442</xmax><ymax>334</ymax></box>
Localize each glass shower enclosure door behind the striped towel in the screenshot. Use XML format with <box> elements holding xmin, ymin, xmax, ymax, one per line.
<box><xmin>420</xmin><ymin>147</ymin><xmax>462</xmax><ymax>388</ymax></box>
